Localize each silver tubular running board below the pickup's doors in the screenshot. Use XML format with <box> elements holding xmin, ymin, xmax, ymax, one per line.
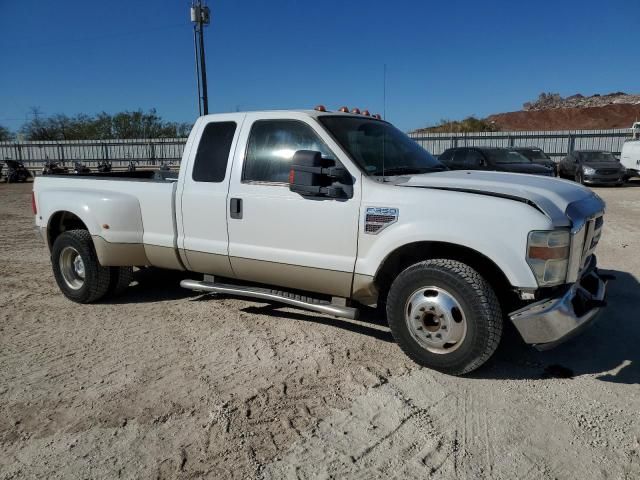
<box><xmin>180</xmin><ymin>280</ymin><xmax>359</xmax><ymax>320</ymax></box>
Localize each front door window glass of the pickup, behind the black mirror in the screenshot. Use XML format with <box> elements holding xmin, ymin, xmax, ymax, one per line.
<box><xmin>242</xmin><ymin>120</ymin><xmax>335</xmax><ymax>183</ymax></box>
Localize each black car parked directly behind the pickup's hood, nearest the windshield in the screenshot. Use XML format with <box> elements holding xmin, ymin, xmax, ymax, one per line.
<box><xmin>438</xmin><ymin>147</ymin><xmax>554</xmax><ymax>177</ymax></box>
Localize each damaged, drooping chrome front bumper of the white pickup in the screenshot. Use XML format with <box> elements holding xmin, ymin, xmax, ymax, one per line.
<box><xmin>509</xmin><ymin>268</ymin><xmax>606</xmax><ymax>350</ymax></box>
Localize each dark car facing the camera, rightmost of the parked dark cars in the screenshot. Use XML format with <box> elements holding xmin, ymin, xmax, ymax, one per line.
<box><xmin>558</xmin><ymin>150</ymin><xmax>627</xmax><ymax>185</ymax></box>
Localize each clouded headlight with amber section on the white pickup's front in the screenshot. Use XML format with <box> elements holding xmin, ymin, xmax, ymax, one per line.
<box><xmin>527</xmin><ymin>230</ymin><xmax>571</xmax><ymax>287</ymax></box>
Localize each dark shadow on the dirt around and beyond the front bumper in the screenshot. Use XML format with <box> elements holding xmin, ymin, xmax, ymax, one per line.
<box><xmin>470</xmin><ymin>270</ymin><xmax>640</xmax><ymax>384</ymax></box>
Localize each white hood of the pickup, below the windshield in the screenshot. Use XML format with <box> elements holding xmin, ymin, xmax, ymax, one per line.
<box><xmin>396</xmin><ymin>170</ymin><xmax>597</xmax><ymax>227</ymax></box>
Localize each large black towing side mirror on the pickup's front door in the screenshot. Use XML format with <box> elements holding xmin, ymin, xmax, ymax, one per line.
<box><xmin>289</xmin><ymin>150</ymin><xmax>347</xmax><ymax>198</ymax></box>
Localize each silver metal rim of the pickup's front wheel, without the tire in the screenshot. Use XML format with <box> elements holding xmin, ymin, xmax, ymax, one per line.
<box><xmin>404</xmin><ymin>287</ymin><xmax>467</xmax><ymax>354</ymax></box>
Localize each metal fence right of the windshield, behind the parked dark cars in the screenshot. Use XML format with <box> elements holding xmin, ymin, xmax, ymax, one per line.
<box><xmin>409</xmin><ymin>128</ymin><xmax>631</xmax><ymax>160</ymax></box>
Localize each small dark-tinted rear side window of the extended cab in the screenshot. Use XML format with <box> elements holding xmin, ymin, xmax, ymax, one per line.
<box><xmin>191</xmin><ymin>122</ymin><xmax>236</xmax><ymax>183</ymax></box>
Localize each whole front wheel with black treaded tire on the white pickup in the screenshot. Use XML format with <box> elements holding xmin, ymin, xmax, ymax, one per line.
<box><xmin>387</xmin><ymin>259</ymin><xmax>502</xmax><ymax>375</ymax></box>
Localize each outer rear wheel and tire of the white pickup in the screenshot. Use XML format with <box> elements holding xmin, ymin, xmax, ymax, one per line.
<box><xmin>51</xmin><ymin>230</ymin><xmax>111</xmax><ymax>303</ymax></box>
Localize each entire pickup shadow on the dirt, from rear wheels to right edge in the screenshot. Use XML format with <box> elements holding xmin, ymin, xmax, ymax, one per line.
<box><xmin>105</xmin><ymin>269</ymin><xmax>640</xmax><ymax>384</ymax></box>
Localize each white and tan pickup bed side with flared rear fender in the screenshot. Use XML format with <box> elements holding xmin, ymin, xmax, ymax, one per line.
<box><xmin>33</xmin><ymin>170</ymin><xmax>180</xmax><ymax>269</ymax></box>
